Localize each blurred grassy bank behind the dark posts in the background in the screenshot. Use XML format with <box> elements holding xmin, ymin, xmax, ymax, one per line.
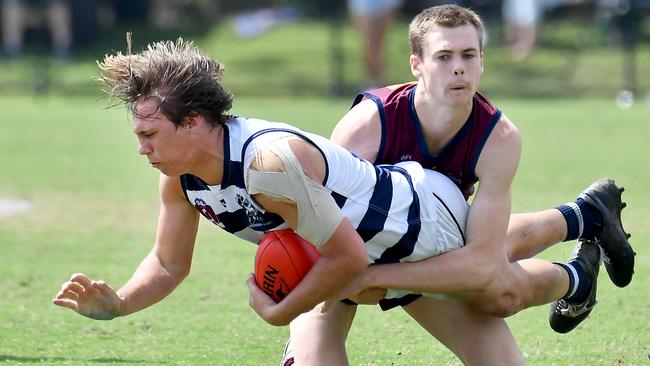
<box><xmin>0</xmin><ymin>18</ymin><xmax>650</xmax><ymax>99</ymax></box>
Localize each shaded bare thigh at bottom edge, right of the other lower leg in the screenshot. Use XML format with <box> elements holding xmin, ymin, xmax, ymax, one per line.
<box><xmin>404</xmin><ymin>297</ymin><xmax>526</xmax><ymax>365</ymax></box>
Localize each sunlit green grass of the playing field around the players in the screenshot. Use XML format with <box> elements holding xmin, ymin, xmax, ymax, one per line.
<box><xmin>0</xmin><ymin>97</ymin><xmax>650</xmax><ymax>366</ymax></box>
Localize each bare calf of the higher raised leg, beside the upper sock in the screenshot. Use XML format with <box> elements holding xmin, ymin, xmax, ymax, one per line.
<box><xmin>504</xmin><ymin>209</ymin><xmax>567</xmax><ymax>262</ymax></box>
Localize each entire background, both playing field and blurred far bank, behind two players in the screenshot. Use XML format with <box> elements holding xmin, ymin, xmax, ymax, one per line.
<box><xmin>0</xmin><ymin>0</ymin><xmax>650</xmax><ymax>366</ymax></box>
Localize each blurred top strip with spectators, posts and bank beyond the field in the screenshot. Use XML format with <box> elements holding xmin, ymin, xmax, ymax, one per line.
<box><xmin>0</xmin><ymin>0</ymin><xmax>650</xmax><ymax>103</ymax></box>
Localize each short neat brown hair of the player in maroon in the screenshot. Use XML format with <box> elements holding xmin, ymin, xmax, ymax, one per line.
<box><xmin>409</xmin><ymin>5</ymin><xmax>483</xmax><ymax>57</ymax></box>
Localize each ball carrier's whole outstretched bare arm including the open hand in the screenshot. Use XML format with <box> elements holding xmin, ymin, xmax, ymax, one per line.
<box><xmin>53</xmin><ymin>175</ymin><xmax>198</xmax><ymax>320</ymax></box>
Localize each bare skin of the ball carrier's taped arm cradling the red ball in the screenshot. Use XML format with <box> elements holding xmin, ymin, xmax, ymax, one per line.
<box><xmin>248</xmin><ymin>140</ymin><xmax>368</xmax><ymax>325</ymax></box>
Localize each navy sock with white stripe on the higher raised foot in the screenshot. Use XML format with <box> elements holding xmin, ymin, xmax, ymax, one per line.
<box><xmin>555</xmin><ymin>198</ymin><xmax>603</xmax><ymax>241</ymax></box>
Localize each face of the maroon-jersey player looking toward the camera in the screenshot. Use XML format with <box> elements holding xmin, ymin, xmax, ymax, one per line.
<box><xmin>411</xmin><ymin>25</ymin><xmax>483</xmax><ymax>106</ymax></box>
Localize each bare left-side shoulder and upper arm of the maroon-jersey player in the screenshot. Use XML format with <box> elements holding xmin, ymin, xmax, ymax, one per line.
<box><xmin>330</xmin><ymin>99</ymin><xmax>381</xmax><ymax>161</ymax></box>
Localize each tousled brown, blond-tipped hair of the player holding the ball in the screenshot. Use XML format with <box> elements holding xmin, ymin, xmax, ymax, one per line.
<box><xmin>97</xmin><ymin>35</ymin><xmax>232</xmax><ymax>125</ymax></box>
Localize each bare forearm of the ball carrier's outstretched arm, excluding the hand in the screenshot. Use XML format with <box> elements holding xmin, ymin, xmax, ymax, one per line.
<box><xmin>117</xmin><ymin>253</ymin><xmax>185</xmax><ymax>316</ymax></box>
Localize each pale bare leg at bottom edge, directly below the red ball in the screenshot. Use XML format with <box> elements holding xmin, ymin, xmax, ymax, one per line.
<box><xmin>290</xmin><ymin>302</ymin><xmax>357</xmax><ymax>366</ymax></box>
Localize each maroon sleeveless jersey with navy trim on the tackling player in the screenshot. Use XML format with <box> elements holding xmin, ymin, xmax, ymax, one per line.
<box><xmin>352</xmin><ymin>82</ymin><xmax>501</xmax><ymax>198</ymax></box>
